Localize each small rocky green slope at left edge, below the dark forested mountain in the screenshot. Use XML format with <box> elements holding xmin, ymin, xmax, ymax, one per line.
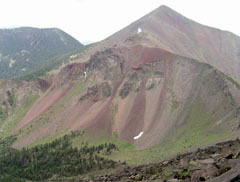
<box><xmin>0</xmin><ymin>80</ymin><xmax>44</xmax><ymax>137</ymax></box>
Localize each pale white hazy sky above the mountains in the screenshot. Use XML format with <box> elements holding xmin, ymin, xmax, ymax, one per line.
<box><xmin>0</xmin><ymin>0</ymin><xmax>240</xmax><ymax>43</ymax></box>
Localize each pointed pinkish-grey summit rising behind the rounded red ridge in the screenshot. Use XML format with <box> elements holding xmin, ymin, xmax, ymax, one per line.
<box><xmin>72</xmin><ymin>6</ymin><xmax>240</xmax><ymax>81</ymax></box>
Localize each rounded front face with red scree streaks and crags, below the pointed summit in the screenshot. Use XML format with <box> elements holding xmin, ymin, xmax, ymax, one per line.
<box><xmin>9</xmin><ymin>46</ymin><xmax>240</xmax><ymax>158</ymax></box>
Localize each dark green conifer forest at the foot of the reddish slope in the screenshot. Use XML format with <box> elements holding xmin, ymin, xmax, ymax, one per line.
<box><xmin>0</xmin><ymin>132</ymin><xmax>117</xmax><ymax>182</ymax></box>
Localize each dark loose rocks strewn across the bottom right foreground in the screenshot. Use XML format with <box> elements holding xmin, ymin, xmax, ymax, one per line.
<box><xmin>92</xmin><ymin>139</ymin><xmax>240</xmax><ymax>182</ymax></box>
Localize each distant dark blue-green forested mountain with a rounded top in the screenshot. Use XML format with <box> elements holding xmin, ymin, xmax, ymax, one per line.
<box><xmin>0</xmin><ymin>27</ymin><xmax>83</xmax><ymax>79</ymax></box>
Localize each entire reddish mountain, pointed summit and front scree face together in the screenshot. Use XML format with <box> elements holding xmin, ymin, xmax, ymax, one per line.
<box><xmin>1</xmin><ymin>6</ymin><xmax>240</xmax><ymax>167</ymax></box>
